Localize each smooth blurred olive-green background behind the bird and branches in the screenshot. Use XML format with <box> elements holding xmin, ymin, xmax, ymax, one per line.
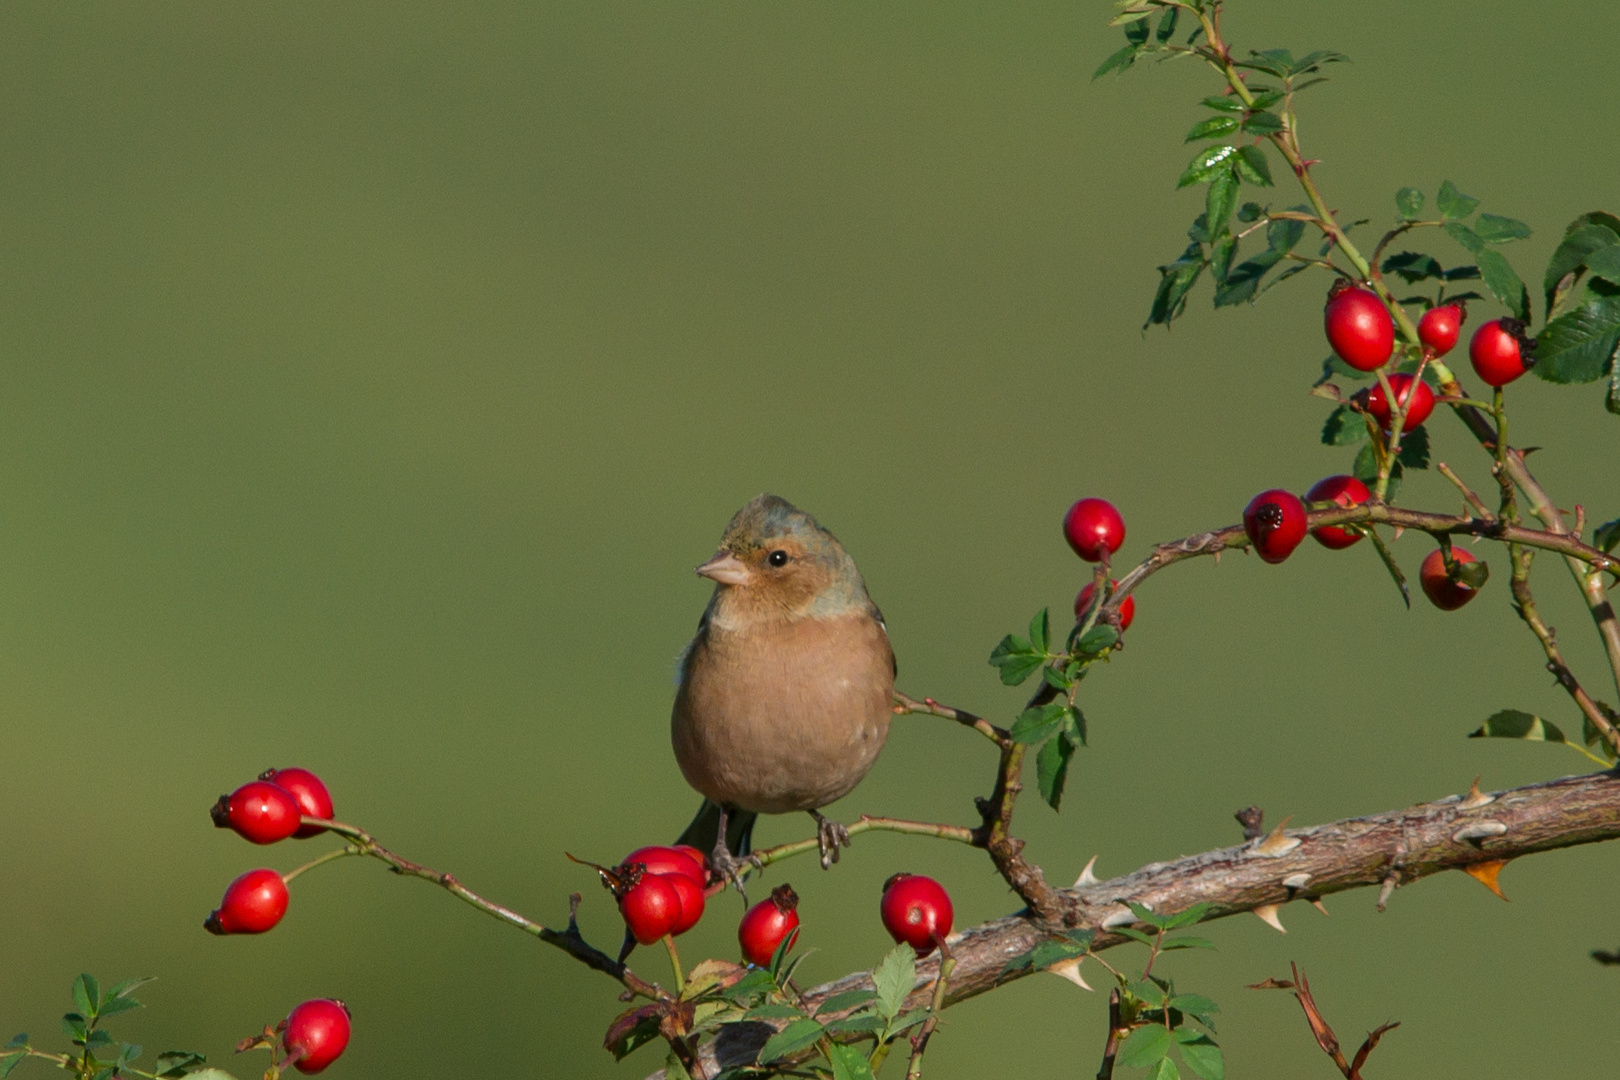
<box><xmin>0</xmin><ymin>0</ymin><xmax>1620</xmax><ymax>1078</ymax></box>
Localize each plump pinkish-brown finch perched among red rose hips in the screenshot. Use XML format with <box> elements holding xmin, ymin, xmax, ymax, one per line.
<box><xmin>671</xmin><ymin>494</ymin><xmax>897</xmax><ymax>887</ymax></box>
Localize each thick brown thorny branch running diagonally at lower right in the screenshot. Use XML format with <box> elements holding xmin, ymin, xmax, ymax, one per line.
<box><xmin>654</xmin><ymin>772</ymin><xmax>1620</xmax><ymax>1070</ymax></box>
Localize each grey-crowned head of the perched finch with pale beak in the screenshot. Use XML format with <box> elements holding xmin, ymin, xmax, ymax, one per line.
<box><xmin>698</xmin><ymin>495</ymin><xmax>870</xmax><ymax>619</ymax></box>
